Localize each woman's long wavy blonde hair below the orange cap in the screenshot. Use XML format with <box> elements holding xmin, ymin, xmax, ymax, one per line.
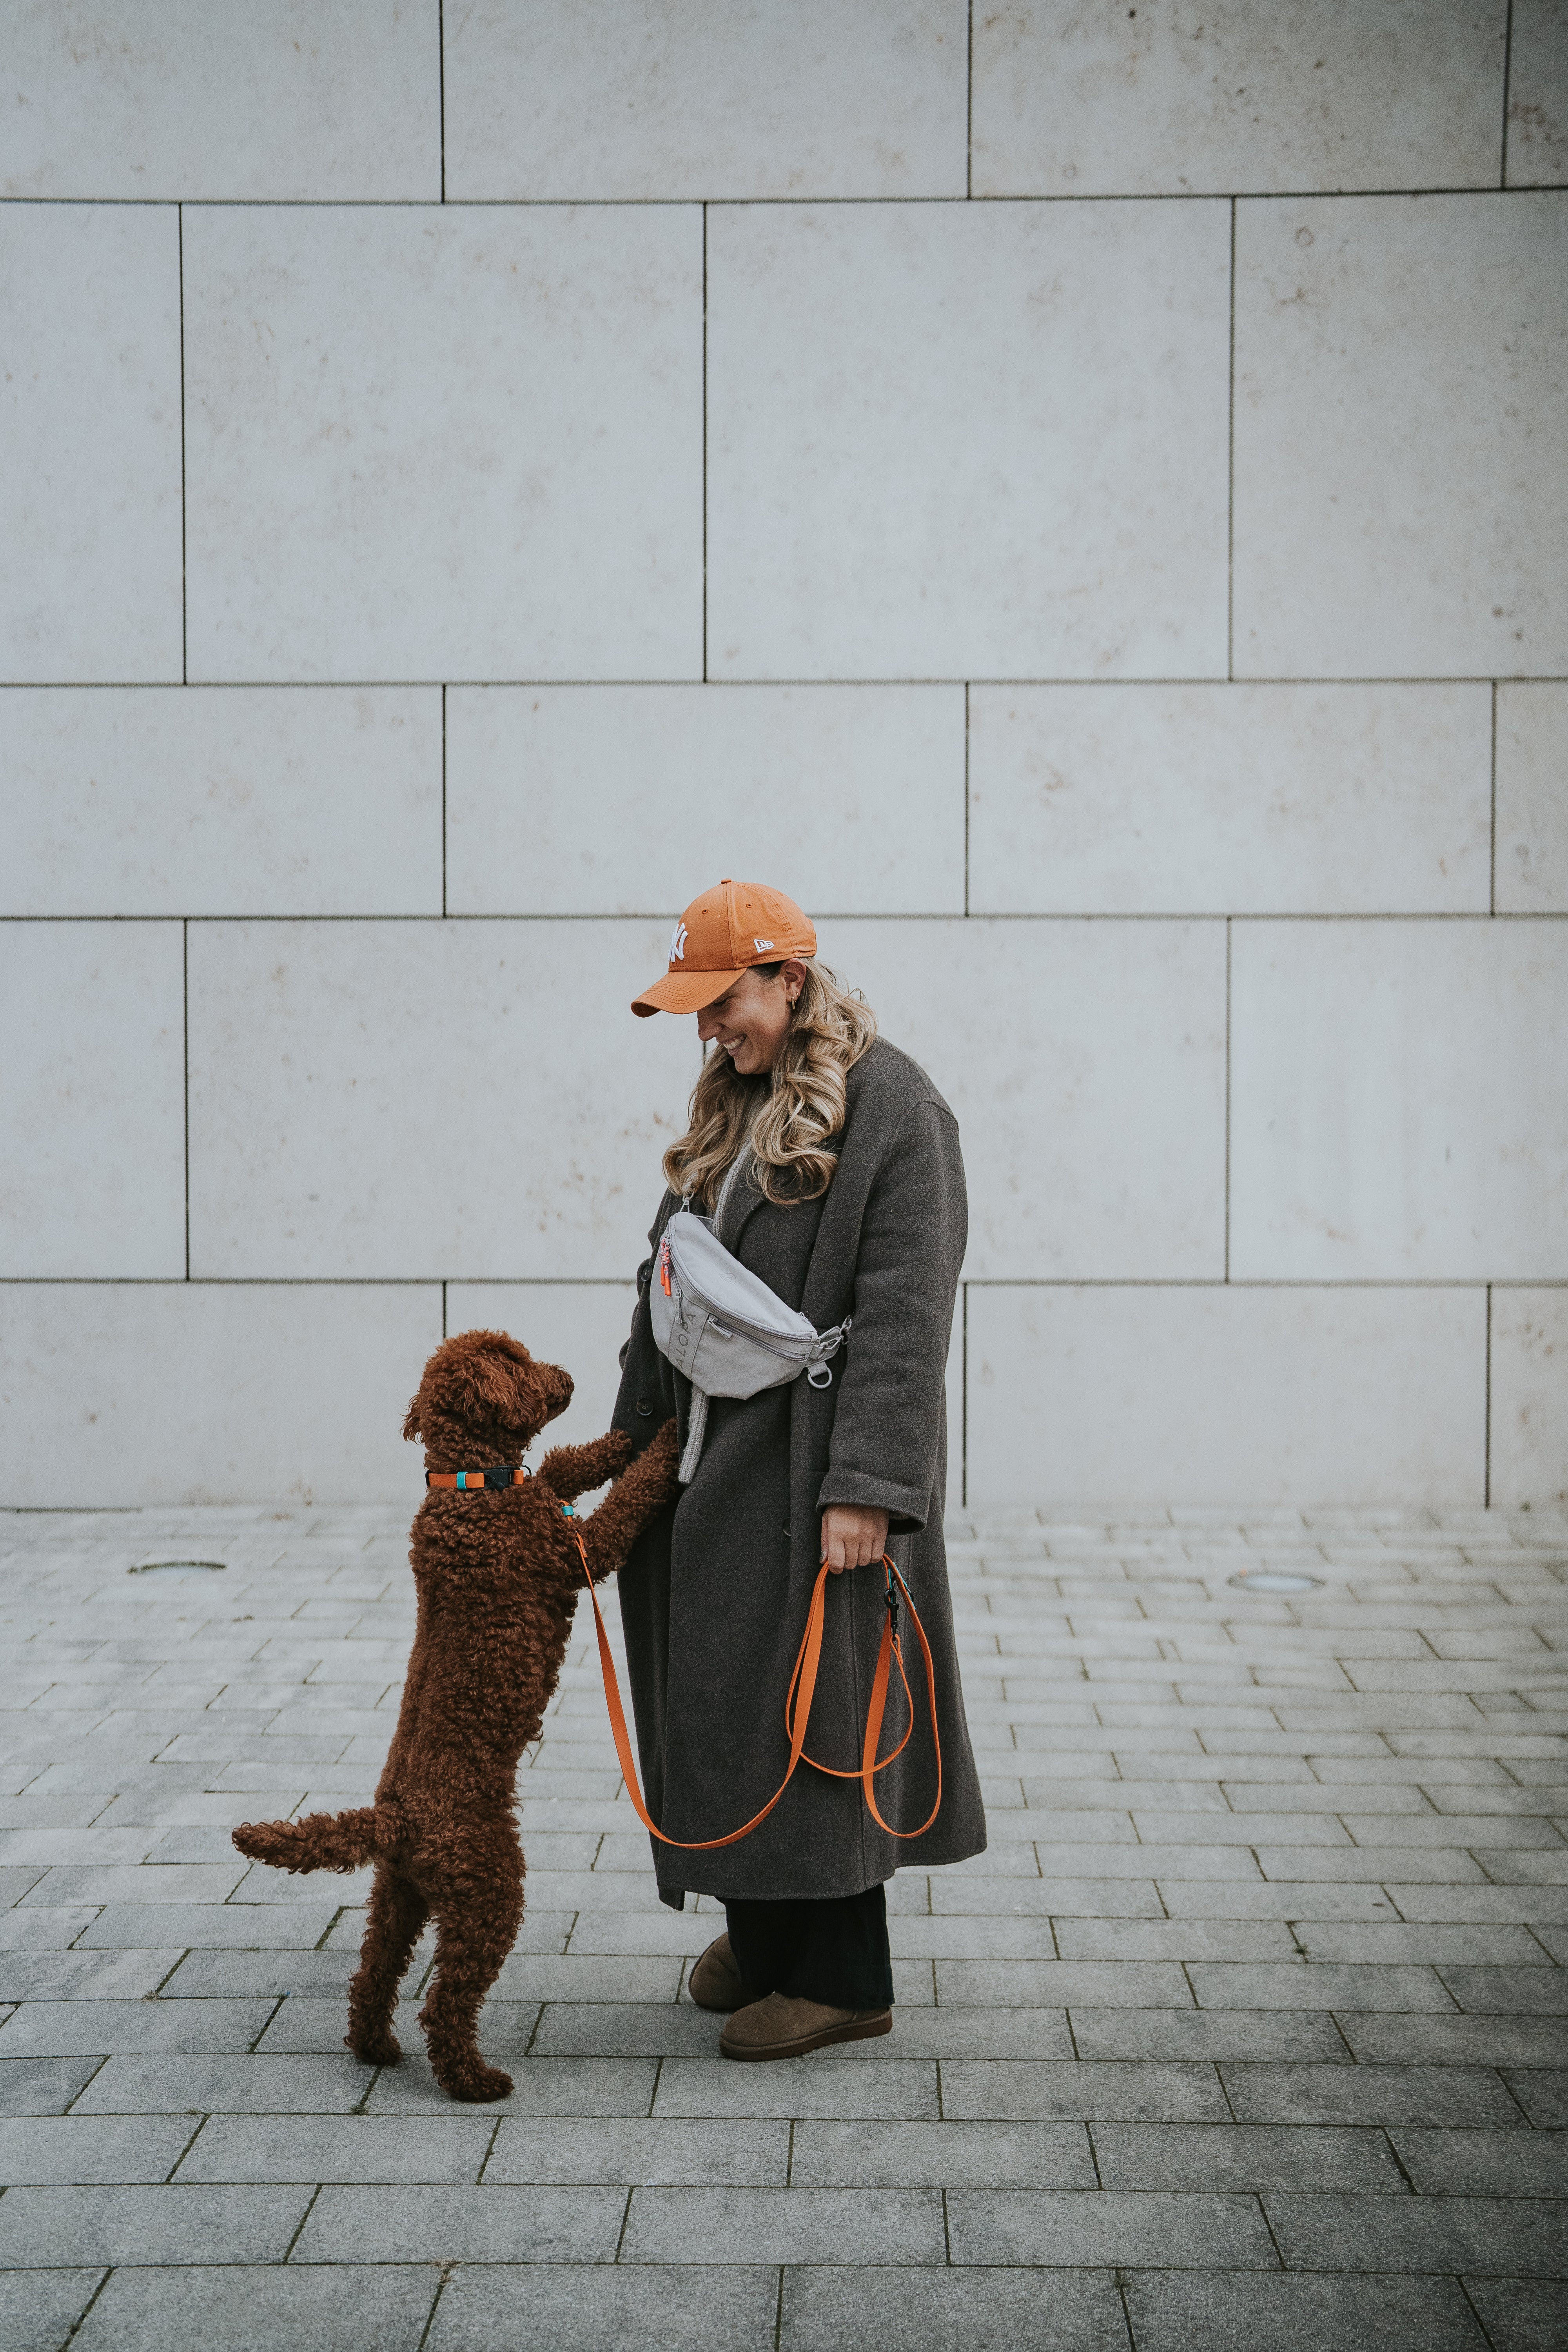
<box><xmin>663</xmin><ymin>964</ymin><xmax>877</xmax><ymax>1211</ymax></box>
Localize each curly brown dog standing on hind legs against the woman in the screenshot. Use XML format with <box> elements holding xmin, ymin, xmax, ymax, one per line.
<box><xmin>235</xmin><ymin>1331</ymin><xmax>677</xmax><ymax>2100</ymax></box>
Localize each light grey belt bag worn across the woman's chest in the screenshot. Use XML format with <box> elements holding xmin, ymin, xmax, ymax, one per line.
<box><xmin>649</xmin><ymin>1207</ymin><xmax>851</xmax><ymax>1397</ymax></box>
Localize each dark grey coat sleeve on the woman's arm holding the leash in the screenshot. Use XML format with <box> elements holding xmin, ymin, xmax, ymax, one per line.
<box><xmin>818</xmin><ymin>1101</ymin><xmax>969</xmax><ymax>1531</ymax></box>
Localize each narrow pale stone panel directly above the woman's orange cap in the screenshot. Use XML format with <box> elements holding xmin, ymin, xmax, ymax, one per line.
<box><xmin>446</xmin><ymin>687</ymin><xmax>964</xmax><ymax>915</ymax></box>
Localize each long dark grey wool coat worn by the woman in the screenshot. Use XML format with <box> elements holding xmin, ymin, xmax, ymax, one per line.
<box><xmin>616</xmin><ymin>1040</ymin><xmax>985</xmax><ymax>1907</ymax></box>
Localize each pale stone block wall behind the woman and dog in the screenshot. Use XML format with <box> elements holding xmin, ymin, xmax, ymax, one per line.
<box><xmin>0</xmin><ymin>0</ymin><xmax>1568</xmax><ymax>1508</ymax></box>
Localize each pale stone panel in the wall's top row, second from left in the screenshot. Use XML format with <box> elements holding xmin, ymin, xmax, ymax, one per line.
<box><xmin>444</xmin><ymin>0</ymin><xmax>969</xmax><ymax>202</ymax></box>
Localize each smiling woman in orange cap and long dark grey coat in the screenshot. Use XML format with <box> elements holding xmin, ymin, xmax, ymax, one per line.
<box><xmin>616</xmin><ymin>882</ymin><xmax>985</xmax><ymax>2058</ymax></box>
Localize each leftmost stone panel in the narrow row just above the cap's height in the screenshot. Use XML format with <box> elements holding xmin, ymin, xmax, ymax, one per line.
<box><xmin>0</xmin><ymin>687</ymin><xmax>442</xmax><ymax>915</ymax></box>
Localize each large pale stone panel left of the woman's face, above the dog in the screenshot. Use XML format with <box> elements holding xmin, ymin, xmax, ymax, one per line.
<box><xmin>191</xmin><ymin>922</ymin><xmax>696</xmax><ymax>1282</ymax></box>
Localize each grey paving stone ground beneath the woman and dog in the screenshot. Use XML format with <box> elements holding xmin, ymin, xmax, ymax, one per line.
<box><xmin>0</xmin><ymin>1510</ymin><xmax>1568</xmax><ymax>2352</ymax></box>
